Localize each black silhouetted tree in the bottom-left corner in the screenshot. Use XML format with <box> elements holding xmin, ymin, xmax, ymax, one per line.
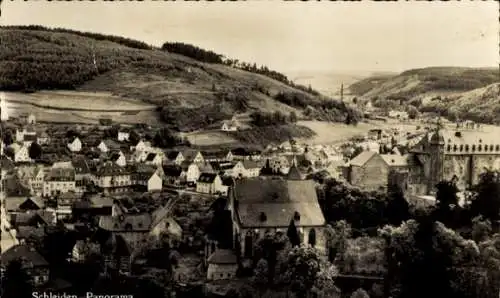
<box><xmin>1</xmin><ymin>260</ymin><xmax>33</xmax><ymax>298</ymax></box>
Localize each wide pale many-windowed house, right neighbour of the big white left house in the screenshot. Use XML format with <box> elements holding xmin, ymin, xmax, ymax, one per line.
<box><xmin>93</xmin><ymin>161</ymin><xmax>132</xmax><ymax>193</ymax></box>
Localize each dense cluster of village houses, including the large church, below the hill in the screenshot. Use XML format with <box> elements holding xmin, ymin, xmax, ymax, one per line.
<box><xmin>0</xmin><ymin>113</ymin><xmax>352</xmax><ymax>289</ymax></box>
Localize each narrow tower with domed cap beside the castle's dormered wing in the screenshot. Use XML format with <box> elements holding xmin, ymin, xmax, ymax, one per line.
<box><xmin>427</xmin><ymin>119</ymin><xmax>445</xmax><ymax>194</ymax></box>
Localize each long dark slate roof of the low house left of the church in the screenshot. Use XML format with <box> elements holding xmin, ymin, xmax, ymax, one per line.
<box><xmin>99</xmin><ymin>213</ymin><xmax>152</xmax><ymax>232</ymax></box>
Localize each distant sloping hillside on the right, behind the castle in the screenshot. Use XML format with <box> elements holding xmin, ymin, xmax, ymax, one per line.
<box><xmin>349</xmin><ymin>67</ymin><xmax>500</xmax><ymax>123</ymax></box>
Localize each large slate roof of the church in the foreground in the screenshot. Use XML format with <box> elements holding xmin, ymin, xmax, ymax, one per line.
<box><xmin>232</xmin><ymin>178</ymin><xmax>325</xmax><ymax>227</ymax></box>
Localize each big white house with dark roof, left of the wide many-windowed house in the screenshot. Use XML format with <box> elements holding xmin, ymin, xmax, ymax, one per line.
<box><xmin>43</xmin><ymin>167</ymin><xmax>76</xmax><ymax>197</ymax></box>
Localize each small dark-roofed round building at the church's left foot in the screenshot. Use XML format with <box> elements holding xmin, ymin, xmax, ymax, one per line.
<box><xmin>207</xmin><ymin>249</ymin><xmax>238</xmax><ymax>280</ymax></box>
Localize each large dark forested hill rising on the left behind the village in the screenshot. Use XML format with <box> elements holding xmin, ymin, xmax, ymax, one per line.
<box><xmin>0</xmin><ymin>26</ymin><xmax>359</xmax><ymax>130</ymax></box>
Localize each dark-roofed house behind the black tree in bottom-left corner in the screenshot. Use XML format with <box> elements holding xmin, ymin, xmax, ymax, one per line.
<box><xmin>0</xmin><ymin>244</ymin><xmax>50</xmax><ymax>287</ymax></box>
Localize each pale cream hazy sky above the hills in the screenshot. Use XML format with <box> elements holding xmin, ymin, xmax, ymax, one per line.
<box><xmin>0</xmin><ymin>0</ymin><xmax>500</xmax><ymax>73</ymax></box>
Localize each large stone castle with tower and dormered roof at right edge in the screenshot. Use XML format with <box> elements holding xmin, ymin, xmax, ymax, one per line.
<box><xmin>407</xmin><ymin>123</ymin><xmax>500</xmax><ymax>195</ymax></box>
